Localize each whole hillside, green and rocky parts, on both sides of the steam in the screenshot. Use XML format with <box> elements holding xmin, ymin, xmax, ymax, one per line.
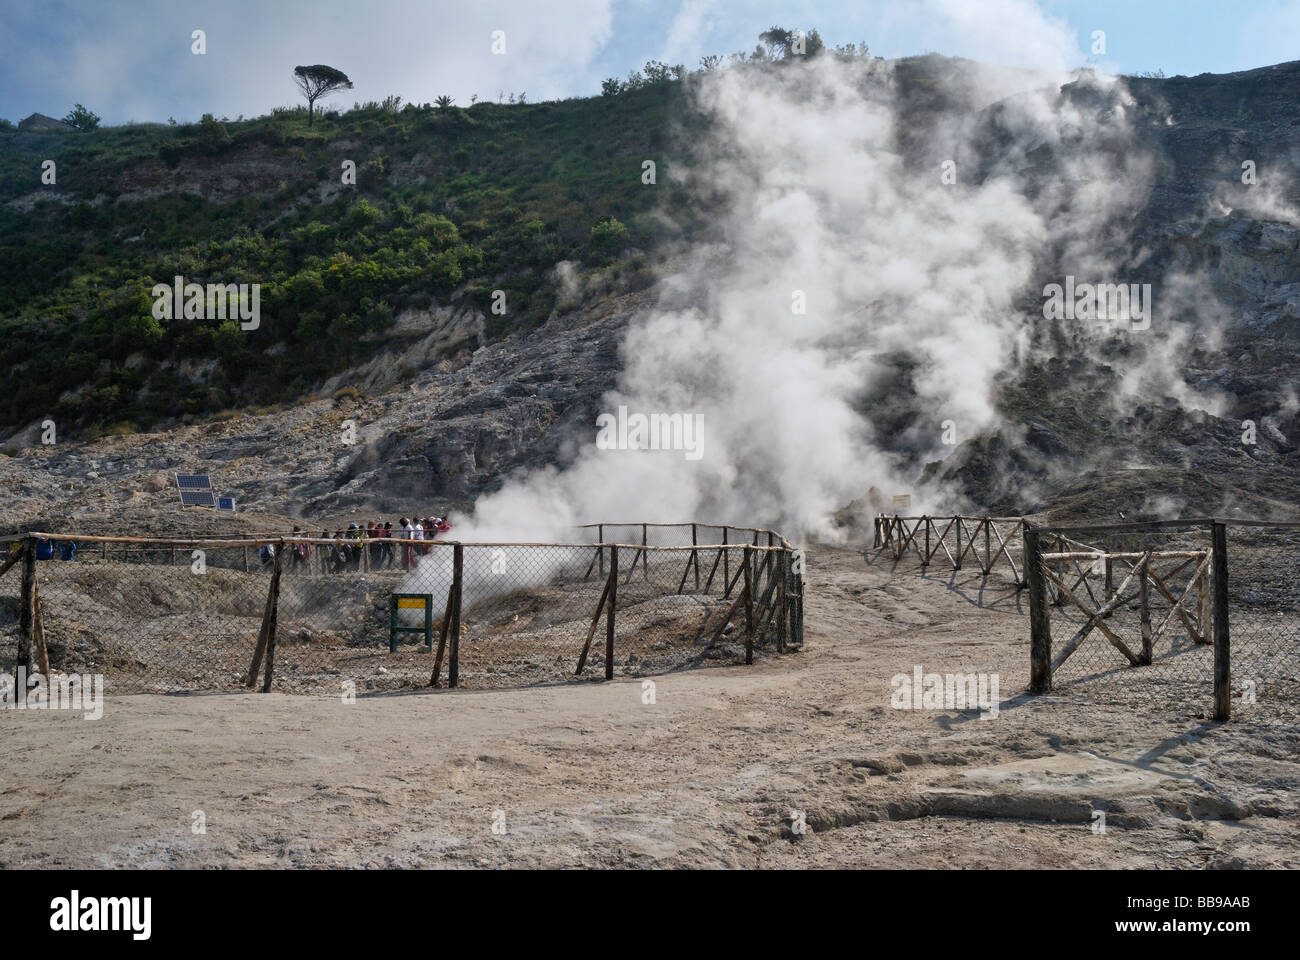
<box><xmin>0</xmin><ymin>56</ymin><xmax>1300</xmax><ymax>526</ymax></box>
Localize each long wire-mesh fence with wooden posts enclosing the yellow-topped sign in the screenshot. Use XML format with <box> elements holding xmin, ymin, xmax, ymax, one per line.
<box><xmin>0</xmin><ymin>524</ymin><xmax>802</xmax><ymax>695</ymax></box>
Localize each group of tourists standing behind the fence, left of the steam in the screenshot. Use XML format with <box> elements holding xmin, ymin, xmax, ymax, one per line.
<box><xmin>261</xmin><ymin>516</ymin><xmax>451</xmax><ymax>574</ymax></box>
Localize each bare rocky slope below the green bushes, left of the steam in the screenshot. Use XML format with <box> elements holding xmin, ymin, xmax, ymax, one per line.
<box><xmin>0</xmin><ymin>287</ymin><xmax>647</xmax><ymax>533</ymax></box>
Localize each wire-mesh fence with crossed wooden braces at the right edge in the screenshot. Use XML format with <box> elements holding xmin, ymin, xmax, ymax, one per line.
<box><xmin>1026</xmin><ymin>520</ymin><xmax>1300</xmax><ymax>719</ymax></box>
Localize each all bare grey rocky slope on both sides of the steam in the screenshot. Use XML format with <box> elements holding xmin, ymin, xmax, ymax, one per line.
<box><xmin>0</xmin><ymin>61</ymin><xmax>1300</xmax><ymax>531</ymax></box>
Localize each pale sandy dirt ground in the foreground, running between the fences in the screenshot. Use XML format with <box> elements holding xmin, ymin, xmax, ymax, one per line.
<box><xmin>0</xmin><ymin>548</ymin><xmax>1300</xmax><ymax>868</ymax></box>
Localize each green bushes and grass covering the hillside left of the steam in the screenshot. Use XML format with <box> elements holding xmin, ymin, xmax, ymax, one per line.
<box><xmin>0</xmin><ymin>83</ymin><xmax>707</xmax><ymax>427</ymax></box>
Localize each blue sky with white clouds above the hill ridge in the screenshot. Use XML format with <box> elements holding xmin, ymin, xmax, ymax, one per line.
<box><xmin>0</xmin><ymin>0</ymin><xmax>1300</xmax><ymax>124</ymax></box>
